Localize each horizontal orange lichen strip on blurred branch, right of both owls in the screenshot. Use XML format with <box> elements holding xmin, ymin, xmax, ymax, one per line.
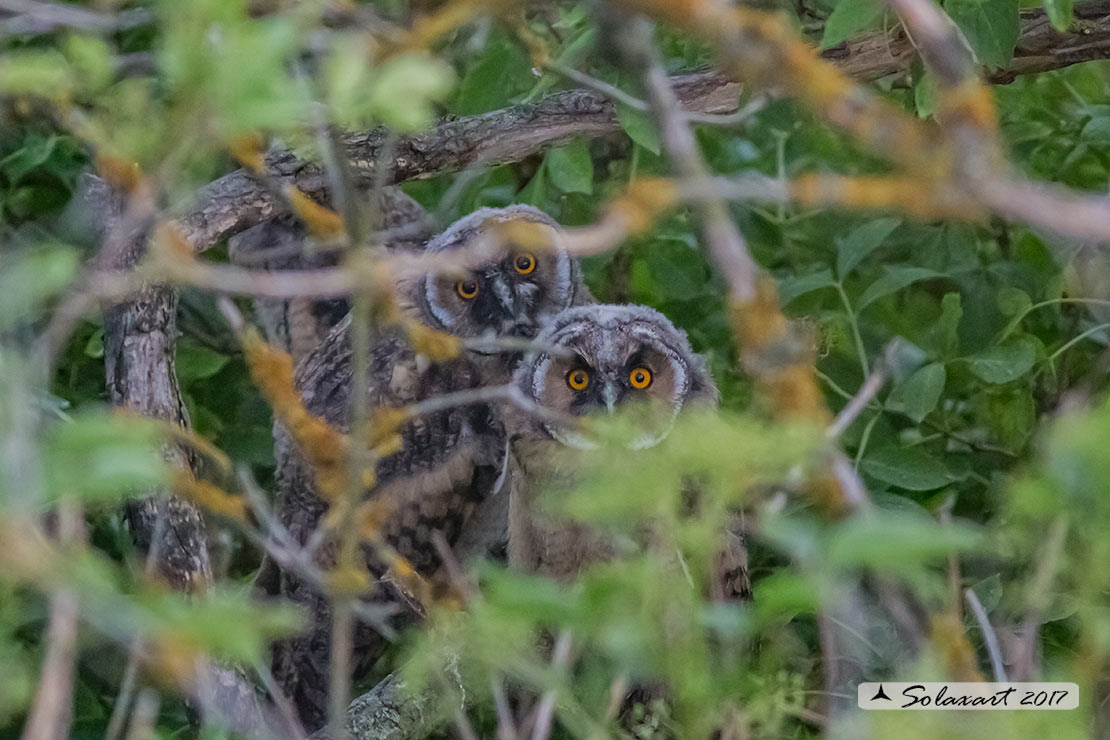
<box><xmin>789</xmin><ymin>174</ymin><xmax>986</xmax><ymax>221</ymax></box>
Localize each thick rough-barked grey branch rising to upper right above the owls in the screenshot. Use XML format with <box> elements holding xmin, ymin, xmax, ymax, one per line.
<box><xmin>179</xmin><ymin>0</ymin><xmax>1110</xmax><ymax>252</ymax></box>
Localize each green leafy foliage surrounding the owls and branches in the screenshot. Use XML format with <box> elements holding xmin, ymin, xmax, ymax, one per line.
<box><xmin>0</xmin><ymin>0</ymin><xmax>1110</xmax><ymax>739</ymax></box>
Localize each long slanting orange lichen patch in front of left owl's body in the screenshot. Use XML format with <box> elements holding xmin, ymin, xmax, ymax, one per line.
<box><xmin>240</xmin><ymin>326</ymin><xmax>351</xmax><ymax>501</ymax></box>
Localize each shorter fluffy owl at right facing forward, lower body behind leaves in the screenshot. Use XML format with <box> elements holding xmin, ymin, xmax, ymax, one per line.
<box><xmin>506</xmin><ymin>305</ymin><xmax>747</xmax><ymax>598</ymax></box>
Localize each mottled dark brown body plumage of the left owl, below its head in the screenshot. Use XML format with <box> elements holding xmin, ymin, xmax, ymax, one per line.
<box><xmin>263</xmin><ymin>320</ymin><xmax>505</xmax><ymax>729</ymax></box>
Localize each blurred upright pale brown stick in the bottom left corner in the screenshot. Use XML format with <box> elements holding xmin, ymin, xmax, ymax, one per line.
<box><xmin>21</xmin><ymin>501</ymin><xmax>84</xmax><ymax>740</ymax></box>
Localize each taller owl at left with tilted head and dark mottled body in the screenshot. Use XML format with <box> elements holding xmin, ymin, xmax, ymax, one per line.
<box><xmin>267</xmin><ymin>205</ymin><xmax>589</xmax><ymax>730</ymax></box>
